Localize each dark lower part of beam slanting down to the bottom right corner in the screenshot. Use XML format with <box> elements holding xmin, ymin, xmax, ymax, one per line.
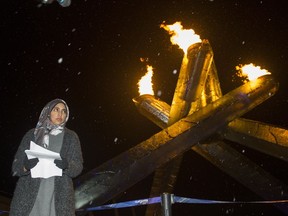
<box><xmin>192</xmin><ymin>141</ymin><xmax>288</xmax><ymax>214</ymax></box>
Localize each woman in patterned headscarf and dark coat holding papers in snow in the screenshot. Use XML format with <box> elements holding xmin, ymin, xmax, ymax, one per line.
<box><xmin>10</xmin><ymin>99</ymin><xmax>83</xmax><ymax>216</ymax></box>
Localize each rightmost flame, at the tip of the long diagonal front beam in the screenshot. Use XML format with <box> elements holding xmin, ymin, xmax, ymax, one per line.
<box><xmin>236</xmin><ymin>63</ymin><xmax>271</xmax><ymax>80</ymax></box>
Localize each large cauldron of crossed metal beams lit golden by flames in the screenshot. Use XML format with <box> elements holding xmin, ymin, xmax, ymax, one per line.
<box><xmin>75</xmin><ymin>37</ymin><xmax>288</xmax><ymax>215</ymax></box>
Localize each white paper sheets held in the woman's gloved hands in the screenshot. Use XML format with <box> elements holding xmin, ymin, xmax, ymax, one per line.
<box><xmin>25</xmin><ymin>141</ymin><xmax>62</xmax><ymax>178</ymax></box>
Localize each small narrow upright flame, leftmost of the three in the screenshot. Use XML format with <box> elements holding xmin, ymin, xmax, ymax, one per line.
<box><xmin>138</xmin><ymin>65</ymin><xmax>154</xmax><ymax>95</ymax></box>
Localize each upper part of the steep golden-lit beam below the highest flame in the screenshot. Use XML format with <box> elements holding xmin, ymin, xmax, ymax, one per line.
<box><xmin>168</xmin><ymin>40</ymin><xmax>213</xmax><ymax>125</ymax></box>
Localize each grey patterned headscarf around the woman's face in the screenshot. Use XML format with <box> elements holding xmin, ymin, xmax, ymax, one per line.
<box><xmin>34</xmin><ymin>99</ymin><xmax>69</xmax><ymax>148</ymax></box>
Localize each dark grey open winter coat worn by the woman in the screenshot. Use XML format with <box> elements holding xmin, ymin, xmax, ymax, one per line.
<box><xmin>10</xmin><ymin>128</ymin><xmax>83</xmax><ymax>216</ymax></box>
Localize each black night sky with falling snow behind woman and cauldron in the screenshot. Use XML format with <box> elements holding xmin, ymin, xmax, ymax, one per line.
<box><xmin>0</xmin><ymin>0</ymin><xmax>288</xmax><ymax>216</ymax></box>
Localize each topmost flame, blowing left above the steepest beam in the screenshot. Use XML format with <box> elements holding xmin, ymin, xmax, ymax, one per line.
<box><xmin>160</xmin><ymin>22</ymin><xmax>202</xmax><ymax>54</ymax></box>
